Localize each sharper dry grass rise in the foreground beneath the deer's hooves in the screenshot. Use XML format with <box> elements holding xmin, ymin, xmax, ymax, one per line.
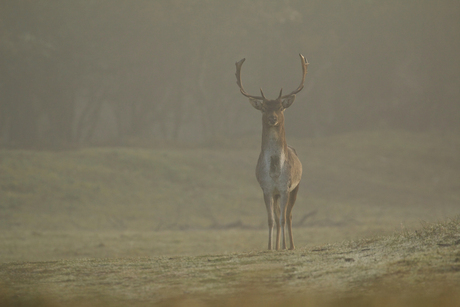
<box><xmin>0</xmin><ymin>217</ymin><xmax>460</xmax><ymax>306</ymax></box>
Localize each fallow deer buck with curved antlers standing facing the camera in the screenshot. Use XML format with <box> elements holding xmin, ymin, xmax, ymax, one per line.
<box><xmin>235</xmin><ymin>54</ymin><xmax>308</xmax><ymax>250</ymax></box>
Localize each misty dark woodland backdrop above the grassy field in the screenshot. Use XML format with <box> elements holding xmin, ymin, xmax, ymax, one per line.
<box><xmin>0</xmin><ymin>0</ymin><xmax>460</xmax><ymax>148</ymax></box>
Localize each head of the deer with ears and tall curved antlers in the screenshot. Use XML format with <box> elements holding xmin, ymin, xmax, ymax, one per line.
<box><xmin>235</xmin><ymin>54</ymin><xmax>308</xmax><ymax>126</ymax></box>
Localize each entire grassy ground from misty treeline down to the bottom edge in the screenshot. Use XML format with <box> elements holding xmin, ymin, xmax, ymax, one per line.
<box><xmin>0</xmin><ymin>131</ymin><xmax>460</xmax><ymax>306</ymax></box>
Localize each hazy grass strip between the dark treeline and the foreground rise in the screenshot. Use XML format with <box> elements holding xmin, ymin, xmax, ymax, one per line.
<box><xmin>0</xmin><ymin>131</ymin><xmax>460</xmax><ymax>262</ymax></box>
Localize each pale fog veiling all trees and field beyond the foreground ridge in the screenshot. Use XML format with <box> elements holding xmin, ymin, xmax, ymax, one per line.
<box><xmin>0</xmin><ymin>0</ymin><xmax>460</xmax><ymax>262</ymax></box>
